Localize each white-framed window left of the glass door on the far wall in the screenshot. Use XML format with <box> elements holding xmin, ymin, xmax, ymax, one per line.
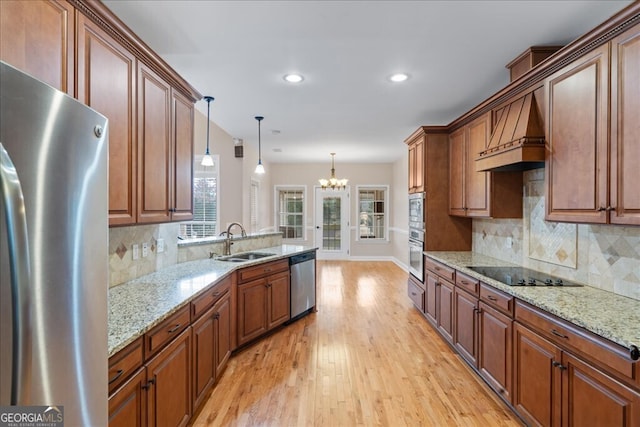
<box><xmin>276</xmin><ymin>187</ymin><xmax>306</xmax><ymax>240</ymax></box>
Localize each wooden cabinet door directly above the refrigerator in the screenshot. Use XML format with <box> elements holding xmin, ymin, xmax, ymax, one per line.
<box><xmin>0</xmin><ymin>0</ymin><xmax>75</xmax><ymax>96</ymax></box>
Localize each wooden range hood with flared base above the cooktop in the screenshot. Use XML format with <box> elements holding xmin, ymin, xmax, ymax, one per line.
<box><xmin>476</xmin><ymin>93</ymin><xmax>545</xmax><ymax>172</ymax></box>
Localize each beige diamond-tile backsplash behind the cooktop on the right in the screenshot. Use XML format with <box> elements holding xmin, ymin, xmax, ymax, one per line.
<box><xmin>473</xmin><ymin>169</ymin><xmax>640</xmax><ymax>300</ymax></box>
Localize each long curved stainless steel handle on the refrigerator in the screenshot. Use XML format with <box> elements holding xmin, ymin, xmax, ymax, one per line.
<box><xmin>0</xmin><ymin>143</ymin><xmax>31</xmax><ymax>405</ymax></box>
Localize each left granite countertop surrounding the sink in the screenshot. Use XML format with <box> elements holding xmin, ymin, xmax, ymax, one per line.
<box><xmin>107</xmin><ymin>245</ymin><xmax>317</xmax><ymax>357</ymax></box>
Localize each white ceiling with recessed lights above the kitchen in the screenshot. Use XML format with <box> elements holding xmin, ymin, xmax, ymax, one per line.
<box><xmin>104</xmin><ymin>0</ymin><xmax>631</xmax><ymax>162</ymax></box>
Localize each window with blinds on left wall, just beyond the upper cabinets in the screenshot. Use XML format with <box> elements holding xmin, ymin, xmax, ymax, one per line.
<box><xmin>180</xmin><ymin>155</ymin><xmax>220</xmax><ymax>239</ymax></box>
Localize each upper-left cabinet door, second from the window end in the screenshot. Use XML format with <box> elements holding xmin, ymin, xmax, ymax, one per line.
<box><xmin>138</xmin><ymin>64</ymin><xmax>171</xmax><ymax>223</ymax></box>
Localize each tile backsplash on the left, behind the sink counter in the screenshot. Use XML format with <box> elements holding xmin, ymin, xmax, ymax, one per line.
<box><xmin>109</xmin><ymin>223</ymin><xmax>282</xmax><ymax>287</ymax></box>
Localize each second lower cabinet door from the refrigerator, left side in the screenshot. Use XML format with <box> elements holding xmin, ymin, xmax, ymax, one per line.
<box><xmin>147</xmin><ymin>328</ymin><xmax>191</xmax><ymax>427</ymax></box>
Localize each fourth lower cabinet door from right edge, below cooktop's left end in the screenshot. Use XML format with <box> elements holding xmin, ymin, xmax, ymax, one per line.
<box><xmin>453</xmin><ymin>288</ymin><xmax>478</xmax><ymax>366</ymax></box>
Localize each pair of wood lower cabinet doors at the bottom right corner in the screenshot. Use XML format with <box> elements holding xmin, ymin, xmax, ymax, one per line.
<box><xmin>513</xmin><ymin>323</ymin><xmax>640</xmax><ymax>427</ymax></box>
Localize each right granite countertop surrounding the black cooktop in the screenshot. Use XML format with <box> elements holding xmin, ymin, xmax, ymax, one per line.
<box><xmin>425</xmin><ymin>251</ymin><xmax>640</xmax><ymax>354</ymax></box>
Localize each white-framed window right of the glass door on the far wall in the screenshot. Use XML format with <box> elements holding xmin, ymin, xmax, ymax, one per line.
<box><xmin>357</xmin><ymin>186</ymin><xmax>389</xmax><ymax>241</ymax></box>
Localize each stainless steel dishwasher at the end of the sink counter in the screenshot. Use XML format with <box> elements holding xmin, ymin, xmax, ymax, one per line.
<box><xmin>289</xmin><ymin>251</ymin><xmax>316</xmax><ymax>321</ymax></box>
